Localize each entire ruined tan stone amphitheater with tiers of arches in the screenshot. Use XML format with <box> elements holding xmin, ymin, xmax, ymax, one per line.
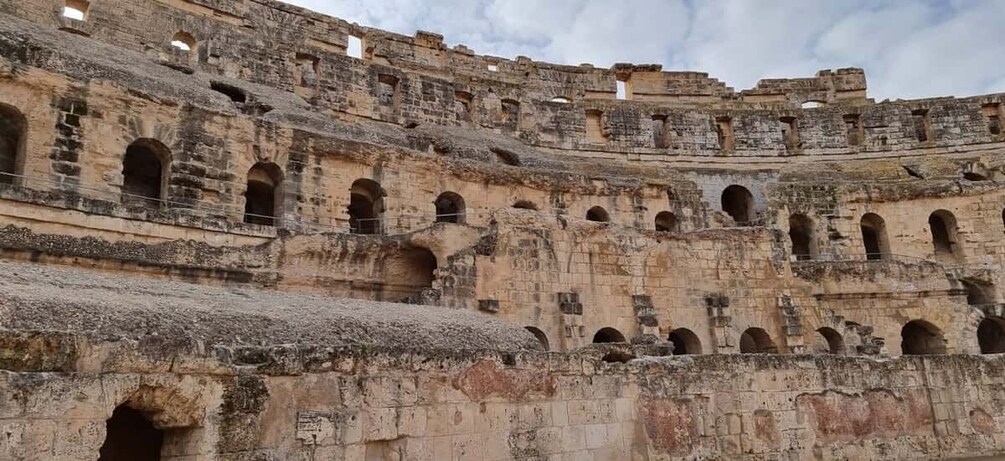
<box><xmin>0</xmin><ymin>0</ymin><xmax>1005</xmax><ymax>461</ymax></box>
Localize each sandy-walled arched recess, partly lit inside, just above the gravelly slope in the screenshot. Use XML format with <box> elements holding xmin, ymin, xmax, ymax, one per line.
<box><xmin>384</xmin><ymin>247</ymin><xmax>436</xmax><ymax>304</ymax></box>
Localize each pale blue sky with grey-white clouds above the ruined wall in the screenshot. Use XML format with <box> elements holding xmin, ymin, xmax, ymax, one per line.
<box><xmin>285</xmin><ymin>0</ymin><xmax>1005</xmax><ymax>99</ymax></box>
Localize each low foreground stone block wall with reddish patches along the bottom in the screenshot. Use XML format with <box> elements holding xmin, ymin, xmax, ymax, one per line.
<box><xmin>0</xmin><ymin>333</ymin><xmax>1005</xmax><ymax>460</ymax></box>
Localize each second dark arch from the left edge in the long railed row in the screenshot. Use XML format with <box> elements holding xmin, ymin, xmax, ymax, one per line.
<box><xmin>122</xmin><ymin>138</ymin><xmax>171</xmax><ymax>207</ymax></box>
